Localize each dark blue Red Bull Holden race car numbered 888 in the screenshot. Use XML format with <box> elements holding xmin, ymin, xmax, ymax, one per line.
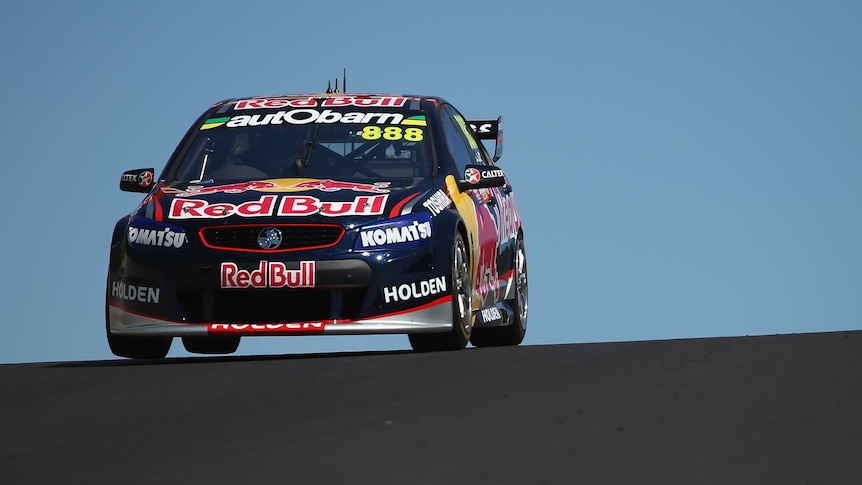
<box><xmin>105</xmin><ymin>92</ymin><xmax>528</xmax><ymax>358</ymax></box>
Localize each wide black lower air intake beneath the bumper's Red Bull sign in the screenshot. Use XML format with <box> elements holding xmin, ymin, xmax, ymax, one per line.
<box><xmin>178</xmin><ymin>288</ymin><xmax>365</xmax><ymax>323</ymax></box>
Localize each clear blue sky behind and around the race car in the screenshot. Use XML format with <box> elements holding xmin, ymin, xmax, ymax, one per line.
<box><xmin>0</xmin><ymin>0</ymin><xmax>862</xmax><ymax>362</ymax></box>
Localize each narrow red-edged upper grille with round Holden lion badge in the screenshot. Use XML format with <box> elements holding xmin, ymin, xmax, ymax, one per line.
<box><xmin>201</xmin><ymin>224</ymin><xmax>344</xmax><ymax>253</ymax></box>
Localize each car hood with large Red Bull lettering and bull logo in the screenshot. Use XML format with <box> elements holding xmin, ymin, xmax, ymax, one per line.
<box><xmin>145</xmin><ymin>178</ymin><xmax>435</xmax><ymax>227</ymax></box>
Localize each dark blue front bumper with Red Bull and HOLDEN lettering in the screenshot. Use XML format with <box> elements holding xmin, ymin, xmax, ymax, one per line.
<box><xmin>106</xmin><ymin>231</ymin><xmax>452</xmax><ymax>336</ymax></box>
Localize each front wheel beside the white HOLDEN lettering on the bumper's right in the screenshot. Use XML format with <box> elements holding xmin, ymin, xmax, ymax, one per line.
<box><xmin>408</xmin><ymin>232</ymin><xmax>473</xmax><ymax>352</ymax></box>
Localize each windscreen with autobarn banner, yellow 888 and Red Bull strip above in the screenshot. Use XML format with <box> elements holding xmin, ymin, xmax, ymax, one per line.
<box><xmin>167</xmin><ymin>96</ymin><xmax>432</xmax><ymax>187</ymax></box>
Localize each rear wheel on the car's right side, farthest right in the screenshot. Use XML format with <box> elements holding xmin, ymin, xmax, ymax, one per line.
<box><xmin>470</xmin><ymin>236</ymin><xmax>529</xmax><ymax>347</ymax></box>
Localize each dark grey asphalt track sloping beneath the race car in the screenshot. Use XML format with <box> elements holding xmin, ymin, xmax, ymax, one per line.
<box><xmin>0</xmin><ymin>332</ymin><xmax>862</xmax><ymax>485</ymax></box>
